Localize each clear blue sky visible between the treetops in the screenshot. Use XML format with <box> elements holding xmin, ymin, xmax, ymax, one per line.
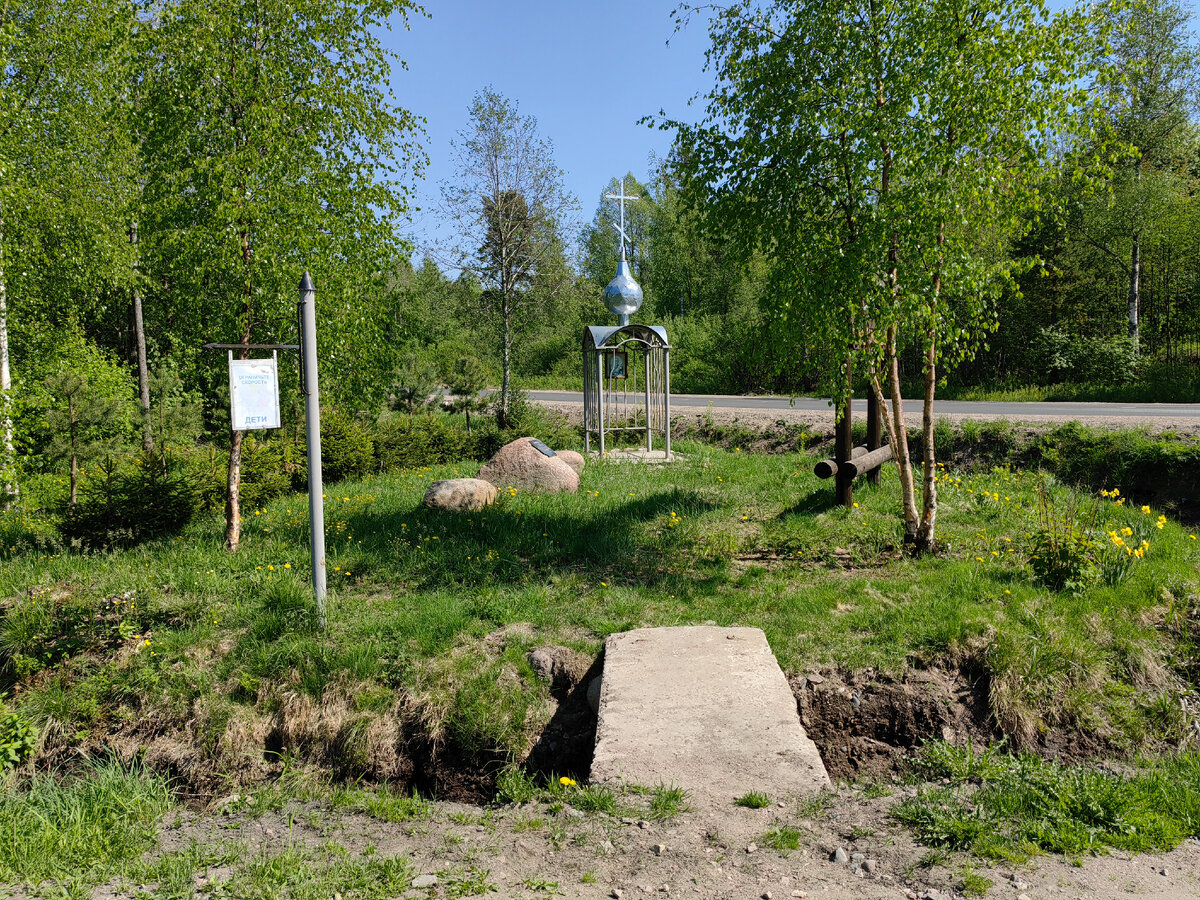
<box><xmin>384</xmin><ymin>0</ymin><xmax>713</xmax><ymax>256</ymax></box>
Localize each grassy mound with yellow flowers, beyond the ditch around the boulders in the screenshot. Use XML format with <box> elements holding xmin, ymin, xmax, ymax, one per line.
<box><xmin>7</xmin><ymin>445</ymin><xmax>1200</xmax><ymax>760</ymax></box>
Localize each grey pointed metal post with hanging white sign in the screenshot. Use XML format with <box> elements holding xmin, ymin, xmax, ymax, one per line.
<box><xmin>204</xmin><ymin>272</ymin><xmax>325</xmax><ymax>628</ymax></box>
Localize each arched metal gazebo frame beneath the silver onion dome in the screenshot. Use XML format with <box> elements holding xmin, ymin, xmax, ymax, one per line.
<box><xmin>583</xmin><ymin>325</ymin><xmax>671</xmax><ymax>460</ymax></box>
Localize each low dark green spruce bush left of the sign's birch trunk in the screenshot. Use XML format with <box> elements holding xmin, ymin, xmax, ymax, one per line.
<box><xmin>59</xmin><ymin>454</ymin><xmax>199</xmax><ymax>547</ymax></box>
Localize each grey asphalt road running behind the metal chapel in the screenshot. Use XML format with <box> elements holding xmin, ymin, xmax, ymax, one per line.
<box><xmin>529</xmin><ymin>391</ymin><xmax>1200</xmax><ymax>421</ymax></box>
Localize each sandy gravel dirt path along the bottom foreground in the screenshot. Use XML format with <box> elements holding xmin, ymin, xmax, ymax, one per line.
<box><xmin>54</xmin><ymin>787</ymin><xmax>1200</xmax><ymax>900</ymax></box>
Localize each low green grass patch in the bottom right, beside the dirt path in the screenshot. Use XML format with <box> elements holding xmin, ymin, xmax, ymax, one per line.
<box><xmin>893</xmin><ymin>742</ymin><xmax>1200</xmax><ymax>862</ymax></box>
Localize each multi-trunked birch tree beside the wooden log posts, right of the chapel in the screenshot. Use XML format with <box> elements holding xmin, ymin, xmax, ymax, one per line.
<box><xmin>665</xmin><ymin>0</ymin><xmax>1103</xmax><ymax>552</ymax></box>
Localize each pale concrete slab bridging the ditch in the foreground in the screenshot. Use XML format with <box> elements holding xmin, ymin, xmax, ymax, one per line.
<box><xmin>592</xmin><ymin>625</ymin><xmax>829</xmax><ymax>803</ymax></box>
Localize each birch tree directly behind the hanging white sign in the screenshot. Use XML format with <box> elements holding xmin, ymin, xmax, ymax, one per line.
<box><xmin>140</xmin><ymin>0</ymin><xmax>424</xmax><ymax>551</ymax></box>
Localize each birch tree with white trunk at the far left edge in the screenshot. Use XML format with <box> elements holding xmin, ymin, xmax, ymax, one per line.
<box><xmin>0</xmin><ymin>0</ymin><xmax>132</xmax><ymax>508</ymax></box>
